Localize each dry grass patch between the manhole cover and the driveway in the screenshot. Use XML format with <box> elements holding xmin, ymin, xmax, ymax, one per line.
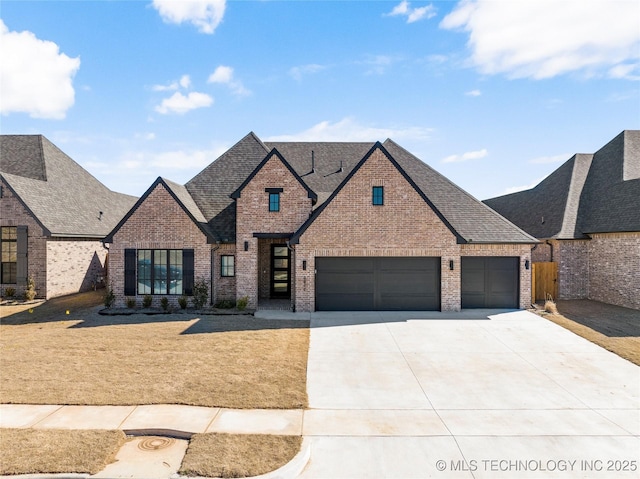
<box><xmin>179</xmin><ymin>434</ymin><xmax>302</xmax><ymax>477</ymax></box>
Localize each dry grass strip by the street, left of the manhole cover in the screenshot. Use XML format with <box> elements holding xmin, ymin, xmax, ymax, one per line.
<box><xmin>0</xmin><ymin>429</ymin><xmax>126</xmax><ymax>474</ymax></box>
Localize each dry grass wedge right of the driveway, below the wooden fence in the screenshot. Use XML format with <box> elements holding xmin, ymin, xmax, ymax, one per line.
<box><xmin>538</xmin><ymin>300</ymin><xmax>640</xmax><ymax>366</ymax></box>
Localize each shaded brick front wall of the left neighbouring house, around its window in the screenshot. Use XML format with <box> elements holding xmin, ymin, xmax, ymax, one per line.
<box><xmin>0</xmin><ymin>181</ymin><xmax>51</xmax><ymax>298</ymax></box>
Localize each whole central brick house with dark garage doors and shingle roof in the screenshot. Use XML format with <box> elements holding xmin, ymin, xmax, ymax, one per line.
<box><xmin>105</xmin><ymin>133</ymin><xmax>537</xmax><ymax>311</ymax></box>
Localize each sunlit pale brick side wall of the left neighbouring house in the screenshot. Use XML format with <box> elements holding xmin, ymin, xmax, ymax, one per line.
<box><xmin>47</xmin><ymin>238</ymin><xmax>107</xmax><ymax>298</ymax></box>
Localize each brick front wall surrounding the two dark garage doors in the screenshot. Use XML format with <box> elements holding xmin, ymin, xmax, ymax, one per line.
<box><xmin>295</xmin><ymin>151</ymin><xmax>531</xmax><ymax>311</ymax></box>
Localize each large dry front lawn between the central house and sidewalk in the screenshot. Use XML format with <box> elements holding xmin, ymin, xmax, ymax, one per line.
<box><xmin>0</xmin><ymin>294</ymin><xmax>309</xmax><ymax>409</ymax></box>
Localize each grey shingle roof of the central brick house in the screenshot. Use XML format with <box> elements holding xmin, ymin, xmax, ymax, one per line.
<box><xmin>109</xmin><ymin>132</ymin><xmax>536</xmax><ymax>243</ymax></box>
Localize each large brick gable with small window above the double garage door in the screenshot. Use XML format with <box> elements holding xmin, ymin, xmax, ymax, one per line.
<box><xmin>291</xmin><ymin>143</ymin><xmax>460</xmax><ymax>249</ymax></box>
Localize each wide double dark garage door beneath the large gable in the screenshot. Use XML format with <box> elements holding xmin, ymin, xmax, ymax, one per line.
<box><xmin>316</xmin><ymin>258</ymin><xmax>440</xmax><ymax>311</ymax></box>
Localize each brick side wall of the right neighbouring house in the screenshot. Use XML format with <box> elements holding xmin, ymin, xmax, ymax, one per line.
<box><xmin>588</xmin><ymin>232</ymin><xmax>640</xmax><ymax>309</ymax></box>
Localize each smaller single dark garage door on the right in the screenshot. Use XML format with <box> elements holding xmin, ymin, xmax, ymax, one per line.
<box><xmin>461</xmin><ymin>257</ymin><xmax>520</xmax><ymax>308</ymax></box>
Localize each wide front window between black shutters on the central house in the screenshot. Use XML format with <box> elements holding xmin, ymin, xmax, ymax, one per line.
<box><xmin>132</xmin><ymin>249</ymin><xmax>188</xmax><ymax>294</ymax></box>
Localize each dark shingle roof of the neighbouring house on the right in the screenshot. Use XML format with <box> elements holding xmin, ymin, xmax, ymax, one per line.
<box><xmin>484</xmin><ymin>130</ymin><xmax>640</xmax><ymax>239</ymax></box>
